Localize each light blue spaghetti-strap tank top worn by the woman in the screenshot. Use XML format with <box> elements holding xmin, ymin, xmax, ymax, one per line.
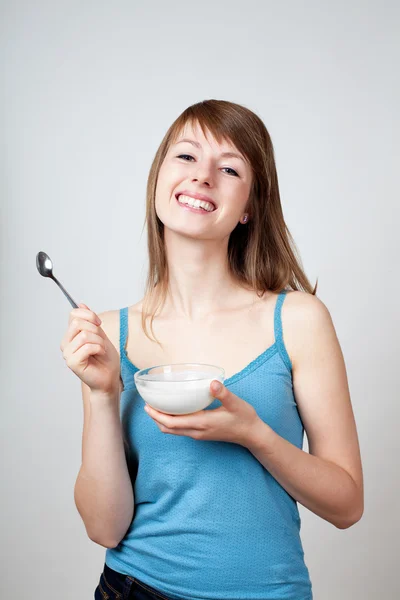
<box><xmin>105</xmin><ymin>290</ymin><xmax>313</xmax><ymax>600</ymax></box>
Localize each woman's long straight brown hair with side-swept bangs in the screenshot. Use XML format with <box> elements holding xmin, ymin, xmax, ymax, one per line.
<box><xmin>142</xmin><ymin>100</ymin><xmax>318</xmax><ymax>345</ymax></box>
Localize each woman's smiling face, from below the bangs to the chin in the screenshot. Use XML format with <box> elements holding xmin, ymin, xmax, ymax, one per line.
<box><xmin>156</xmin><ymin>124</ymin><xmax>252</xmax><ymax>239</ymax></box>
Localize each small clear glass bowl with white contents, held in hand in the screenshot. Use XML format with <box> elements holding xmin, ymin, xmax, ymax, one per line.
<box><xmin>134</xmin><ymin>363</ymin><xmax>225</xmax><ymax>415</ymax></box>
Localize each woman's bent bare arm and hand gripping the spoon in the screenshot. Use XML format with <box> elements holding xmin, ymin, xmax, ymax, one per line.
<box><xmin>61</xmin><ymin>304</ymin><xmax>134</xmax><ymax>548</ymax></box>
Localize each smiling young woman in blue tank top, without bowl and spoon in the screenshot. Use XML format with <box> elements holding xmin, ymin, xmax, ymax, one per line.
<box><xmin>61</xmin><ymin>100</ymin><xmax>363</xmax><ymax>600</ymax></box>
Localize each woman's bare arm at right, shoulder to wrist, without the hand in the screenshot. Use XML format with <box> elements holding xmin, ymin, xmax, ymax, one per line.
<box><xmin>246</xmin><ymin>292</ymin><xmax>364</xmax><ymax>529</ymax></box>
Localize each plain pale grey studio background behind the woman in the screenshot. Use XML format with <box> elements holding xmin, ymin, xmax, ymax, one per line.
<box><xmin>0</xmin><ymin>0</ymin><xmax>400</xmax><ymax>600</ymax></box>
